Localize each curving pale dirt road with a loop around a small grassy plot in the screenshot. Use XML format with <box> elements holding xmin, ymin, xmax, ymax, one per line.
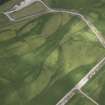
<box><xmin>4</xmin><ymin>0</ymin><xmax>105</xmax><ymax>48</ymax></box>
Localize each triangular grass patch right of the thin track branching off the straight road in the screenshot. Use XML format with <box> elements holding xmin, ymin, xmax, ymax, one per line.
<box><xmin>83</xmin><ymin>67</ymin><xmax>105</xmax><ymax>105</ymax></box>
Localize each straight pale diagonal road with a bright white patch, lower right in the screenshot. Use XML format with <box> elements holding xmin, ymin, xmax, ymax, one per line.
<box><xmin>56</xmin><ymin>57</ymin><xmax>105</xmax><ymax>105</ymax></box>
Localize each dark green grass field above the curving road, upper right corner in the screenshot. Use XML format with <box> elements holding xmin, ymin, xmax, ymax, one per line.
<box><xmin>44</xmin><ymin>0</ymin><xmax>105</xmax><ymax>35</ymax></box>
